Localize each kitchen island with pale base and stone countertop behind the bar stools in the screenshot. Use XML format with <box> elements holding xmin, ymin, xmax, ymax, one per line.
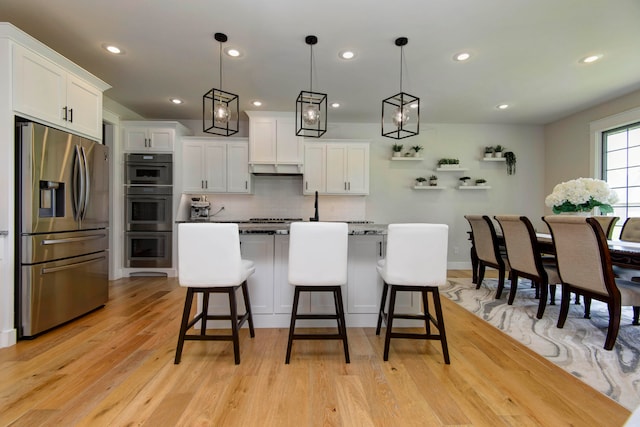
<box><xmin>178</xmin><ymin>221</ymin><xmax>420</xmax><ymax>328</ymax></box>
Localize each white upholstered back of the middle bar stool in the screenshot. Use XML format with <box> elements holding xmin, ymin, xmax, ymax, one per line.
<box><xmin>289</xmin><ymin>222</ymin><xmax>349</xmax><ymax>286</ymax></box>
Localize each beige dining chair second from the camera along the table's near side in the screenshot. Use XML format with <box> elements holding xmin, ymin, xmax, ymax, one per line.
<box><xmin>495</xmin><ymin>215</ymin><xmax>560</xmax><ymax>319</ymax></box>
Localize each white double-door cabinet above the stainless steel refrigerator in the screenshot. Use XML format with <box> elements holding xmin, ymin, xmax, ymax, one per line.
<box><xmin>13</xmin><ymin>45</ymin><xmax>102</xmax><ymax>140</ymax></box>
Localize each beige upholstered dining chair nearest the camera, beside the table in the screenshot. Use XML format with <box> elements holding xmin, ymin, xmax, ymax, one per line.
<box><xmin>543</xmin><ymin>215</ymin><xmax>640</xmax><ymax>350</ymax></box>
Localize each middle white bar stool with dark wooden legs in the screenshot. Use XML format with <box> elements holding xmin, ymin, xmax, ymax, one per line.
<box><xmin>285</xmin><ymin>222</ymin><xmax>349</xmax><ymax>364</ymax></box>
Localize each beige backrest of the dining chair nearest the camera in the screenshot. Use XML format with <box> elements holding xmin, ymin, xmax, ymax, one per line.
<box><xmin>543</xmin><ymin>215</ymin><xmax>616</xmax><ymax>297</ymax></box>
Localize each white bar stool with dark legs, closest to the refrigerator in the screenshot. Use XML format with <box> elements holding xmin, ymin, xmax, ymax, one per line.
<box><xmin>174</xmin><ymin>223</ymin><xmax>255</xmax><ymax>365</ymax></box>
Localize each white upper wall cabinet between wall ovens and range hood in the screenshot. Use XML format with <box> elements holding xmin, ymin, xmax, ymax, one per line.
<box><xmin>181</xmin><ymin>137</ymin><xmax>251</xmax><ymax>194</ymax></box>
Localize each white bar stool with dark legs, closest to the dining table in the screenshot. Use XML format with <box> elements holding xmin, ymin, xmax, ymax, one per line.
<box><xmin>376</xmin><ymin>224</ymin><xmax>449</xmax><ymax>365</ymax></box>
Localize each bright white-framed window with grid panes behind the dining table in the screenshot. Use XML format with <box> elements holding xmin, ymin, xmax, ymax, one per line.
<box><xmin>602</xmin><ymin>122</ymin><xmax>640</xmax><ymax>239</ymax></box>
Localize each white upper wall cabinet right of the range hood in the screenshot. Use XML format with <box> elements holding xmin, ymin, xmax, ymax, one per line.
<box><xmin>303</xmin><ymin>140</ymin><xmax>369</xmax><ymax>195</ymax></box>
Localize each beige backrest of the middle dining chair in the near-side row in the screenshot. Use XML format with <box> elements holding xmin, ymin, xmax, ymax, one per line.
<box><xmin>495</xmin><ymin>215</ymin><xmax>544</xmax><ymax>276</ymax></box>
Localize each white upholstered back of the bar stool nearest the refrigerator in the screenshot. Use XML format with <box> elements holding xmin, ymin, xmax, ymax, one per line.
<box><xmin>178</xmin><ymin>223</ymin><xmax>246</xmax><ymax>287</ymax></box>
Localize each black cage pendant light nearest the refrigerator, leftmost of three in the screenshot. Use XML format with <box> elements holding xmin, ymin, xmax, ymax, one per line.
<box><xmin>202</xmin><ymin>33</ymin><xmax>240</xmax><ymax>136</ymax></box>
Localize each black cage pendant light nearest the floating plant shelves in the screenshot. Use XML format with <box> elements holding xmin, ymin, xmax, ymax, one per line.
<box><xmin>382</xmin><ymin>37</ymin><xmax>420</xmax><ymax>139</ymax></box>
